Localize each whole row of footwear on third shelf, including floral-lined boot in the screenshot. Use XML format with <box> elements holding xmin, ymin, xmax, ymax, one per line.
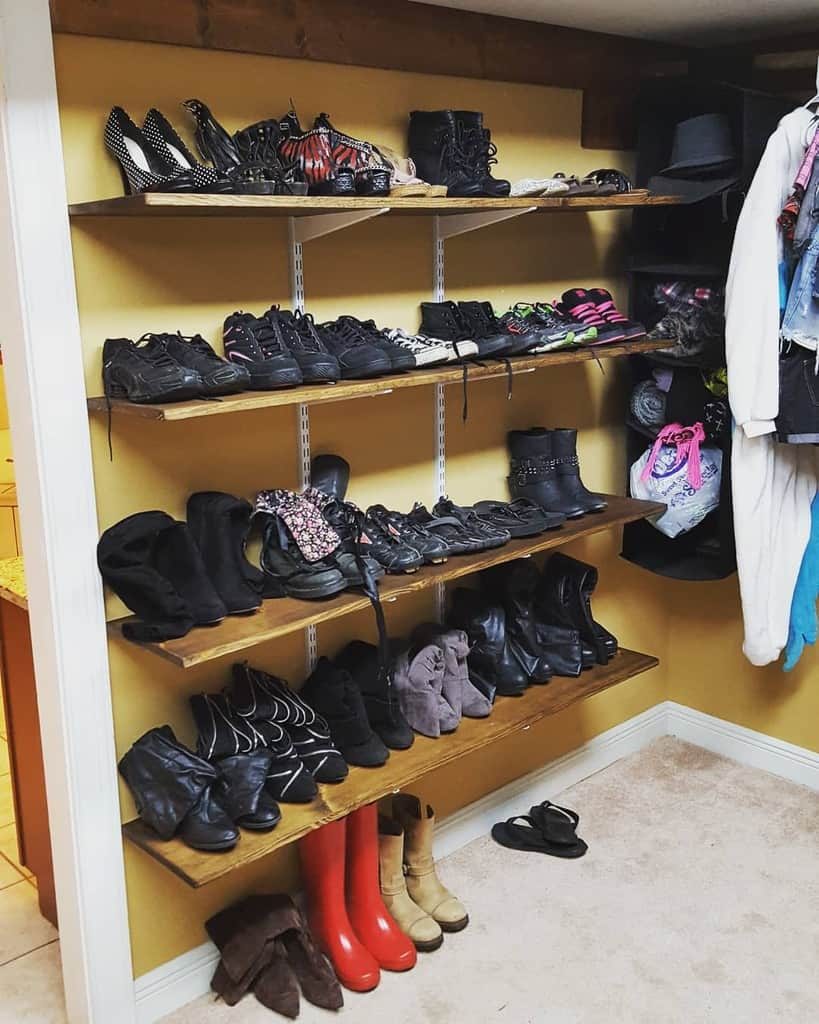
<box><xmin>97</xmin><ymin>436</ymin><xmax>606</xmax><ymax>643</ymax></box>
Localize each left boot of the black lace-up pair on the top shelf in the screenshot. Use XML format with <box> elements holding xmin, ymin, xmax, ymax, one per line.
<box><xmin>408</xmin><ymin>111</ymin><xmax>487</xmax><ymax>198</ymax></box>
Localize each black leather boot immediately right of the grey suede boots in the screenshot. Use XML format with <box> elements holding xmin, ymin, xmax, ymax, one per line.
<box><xmin>446</xmin><ymin>588</ymin><xmax>528</xmax><ymax>700</ymax></box>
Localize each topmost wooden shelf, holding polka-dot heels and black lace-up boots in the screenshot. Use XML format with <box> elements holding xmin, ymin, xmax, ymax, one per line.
<box><xmin>69</xmin><ymin>189</ymin><xmax>680</xmax><ymax>217</ymax></box>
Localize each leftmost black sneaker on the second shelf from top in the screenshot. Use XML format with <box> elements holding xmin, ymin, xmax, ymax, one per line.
<box><xmin>102</xmin><ymin>336</ymin><xmax>202</xmax><ymax>404</ymax></box>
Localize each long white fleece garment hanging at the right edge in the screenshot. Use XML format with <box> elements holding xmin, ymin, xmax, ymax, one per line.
<box><xmin>726</xmin><ymin>108</ymin><xmax>819</xmax><ymax>665</ymax></box>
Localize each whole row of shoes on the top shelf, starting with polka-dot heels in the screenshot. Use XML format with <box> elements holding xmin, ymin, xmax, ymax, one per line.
<box><xmin>103</xmin><ymin>99</ymin><xmax>632</xmax><ymax>199</ymax></box>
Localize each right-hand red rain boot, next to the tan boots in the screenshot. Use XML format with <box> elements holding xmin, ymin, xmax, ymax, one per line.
<box><xmin>347</xmin><ymin>804</ymin><xmax>418</xmax><ymax>971</ymax></box>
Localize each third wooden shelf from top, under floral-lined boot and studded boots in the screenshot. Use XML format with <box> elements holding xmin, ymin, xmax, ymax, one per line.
<box><xmin>109</xmin><ymin>496</ymin><xmax>665</xmax><ymax>669</ymax></box>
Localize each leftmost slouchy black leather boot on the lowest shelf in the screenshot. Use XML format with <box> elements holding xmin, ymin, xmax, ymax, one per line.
<box><xmin>119</xmin><ymin>725</ymin><xmax>239</xmax><ymax>850</ymax></box>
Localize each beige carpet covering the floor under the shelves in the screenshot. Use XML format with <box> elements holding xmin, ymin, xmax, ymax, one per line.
<box><xmin>166</xmin><ymin>739</ymin><xmax>819</xmax><ymax>1024</ymax></box>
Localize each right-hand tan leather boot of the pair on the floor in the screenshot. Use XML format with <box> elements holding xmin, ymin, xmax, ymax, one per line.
<box><xmin>392</xmin><ymin>794</ymin><xmax>469</xmax><ymax>932</ymax></box>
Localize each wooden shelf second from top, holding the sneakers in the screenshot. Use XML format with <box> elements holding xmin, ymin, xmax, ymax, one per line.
<box><xmin>88</xmin><ymin>338</ymin><xmax>674</xmax><ymax>422</ymax></box>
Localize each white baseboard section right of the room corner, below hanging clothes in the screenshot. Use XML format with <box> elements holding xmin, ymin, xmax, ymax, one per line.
<box><xmin>662</xmin><ymin>700</ymin><xmax>819</xmax><ymax>790</ymax></box>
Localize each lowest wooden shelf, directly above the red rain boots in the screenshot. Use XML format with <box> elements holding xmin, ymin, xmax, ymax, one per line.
<box><xmin>123</xmin><ymin>649</ymin><xmax>658</xmax><ymax>888</ymax></box>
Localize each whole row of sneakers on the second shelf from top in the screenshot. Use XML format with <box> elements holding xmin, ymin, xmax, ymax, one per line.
<box><xmin>102</xmin><ymin>288</ymin><xmax>645</xmax><ymax>403</ymax></box>
